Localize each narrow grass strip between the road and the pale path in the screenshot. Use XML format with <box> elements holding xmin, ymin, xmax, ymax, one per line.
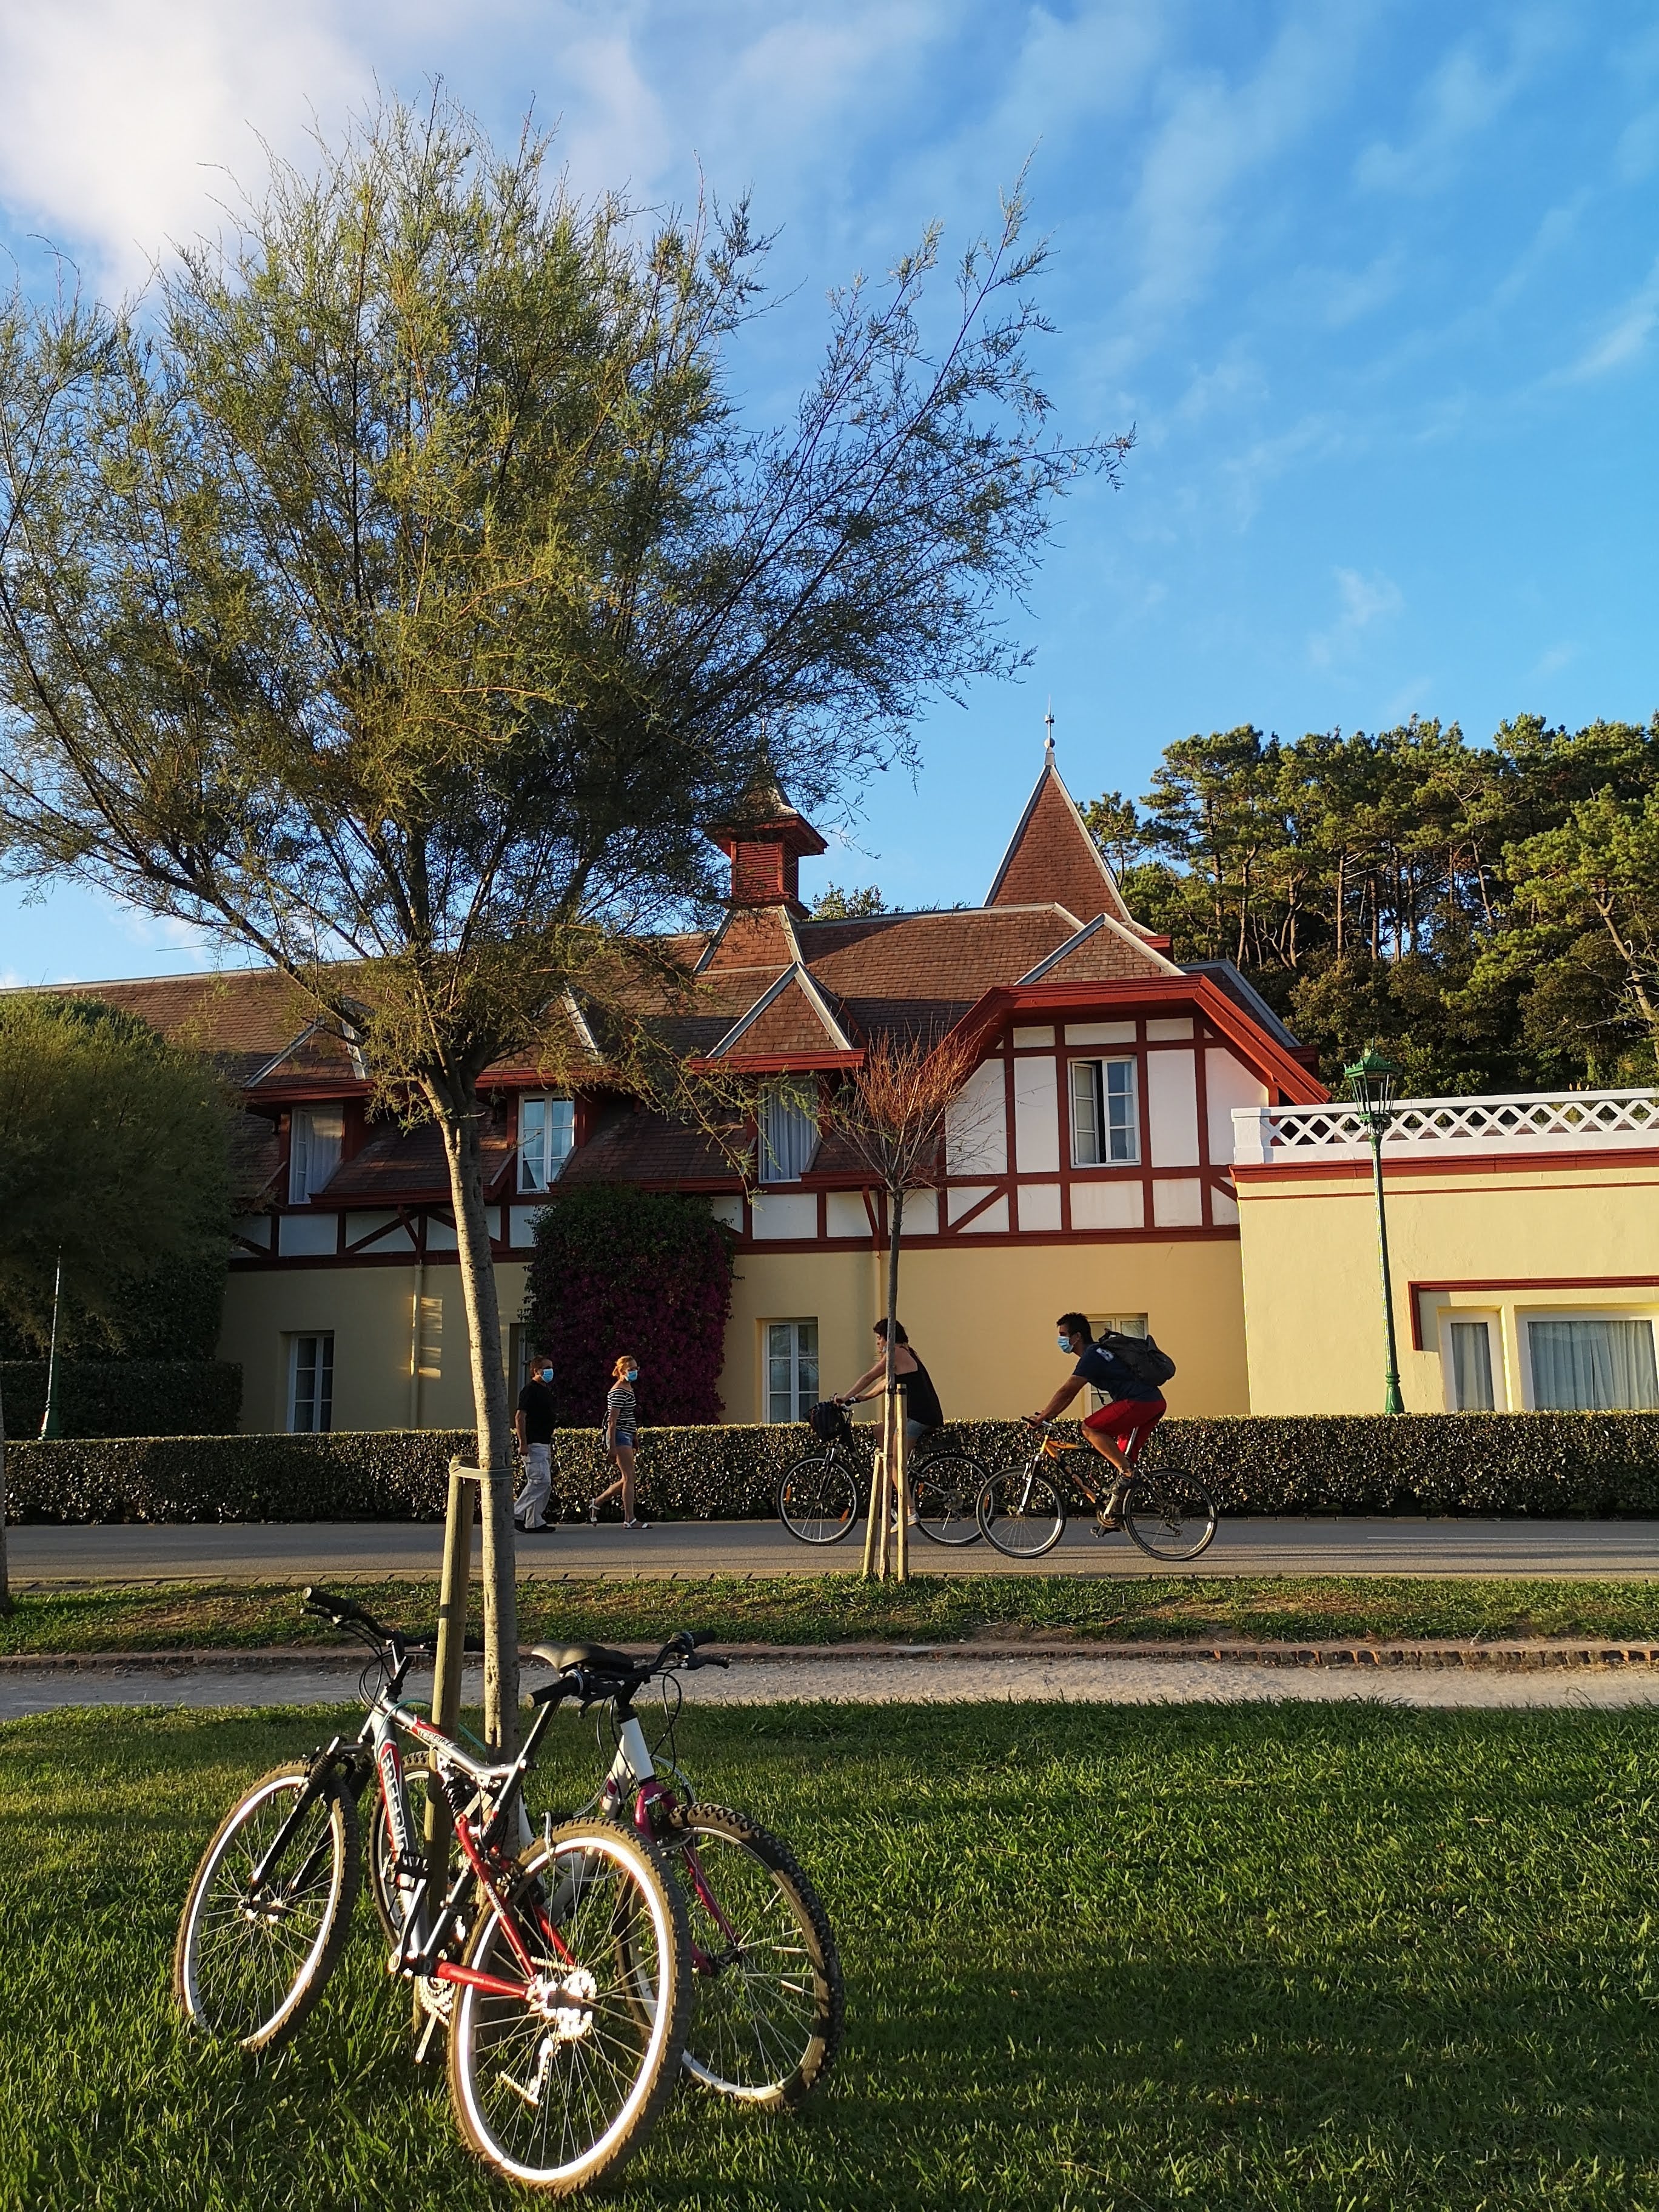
<box><xmin>0</xmin><ymin>1573</ymin><xmax>1659</xmax><ymax>1652</ymax></box>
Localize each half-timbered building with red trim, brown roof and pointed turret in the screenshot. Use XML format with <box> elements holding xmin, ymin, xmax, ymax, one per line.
<box><xmin>68</xmin><ymin>748</ymin><xmax>1325</xmax><ymax>1429</ymax></box>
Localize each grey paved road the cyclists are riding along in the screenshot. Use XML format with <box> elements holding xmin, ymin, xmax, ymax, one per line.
<box><xmin>7</xmin><ymin>1520</ymin><xmax>1659</xmax><ymax>1588</ymax></box>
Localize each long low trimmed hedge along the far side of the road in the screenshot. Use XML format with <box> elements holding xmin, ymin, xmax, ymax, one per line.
<box><xmin>9</xmin><ymin>1413</ymin><xmax>1659</xmax><ymax>1522</ymax></box>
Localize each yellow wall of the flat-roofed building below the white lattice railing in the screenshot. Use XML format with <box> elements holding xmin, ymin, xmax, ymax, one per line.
<box><xmin>1239</xmin><ymin>1153</ymin><xmax>1659</xmax><ymax>1413</ymax></box>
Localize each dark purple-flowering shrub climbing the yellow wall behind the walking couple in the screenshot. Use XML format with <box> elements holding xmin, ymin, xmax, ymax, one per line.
<box><xmin>525</xmin><ymin>1184</ymin><xmax>732</xmax><ymax>1427</ymax></box>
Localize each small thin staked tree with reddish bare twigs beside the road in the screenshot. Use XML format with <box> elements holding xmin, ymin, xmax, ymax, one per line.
<box><xmin>819</xmin><ymin>1031</ymin><xmax>980</xmax><ymax>1581</ymax></box>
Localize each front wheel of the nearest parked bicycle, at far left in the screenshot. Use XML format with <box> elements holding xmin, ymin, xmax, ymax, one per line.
<box><xmin>173</xmin><ymin>1765</ymin><xmax>361</xmax><ymax>2051</ymax></box>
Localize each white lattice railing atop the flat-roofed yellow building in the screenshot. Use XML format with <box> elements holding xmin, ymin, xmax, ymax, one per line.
<box><xmin>1232</xmin><ymin>1090</ymin><xmax>1659</xmax><ymax>1161</ymax></box>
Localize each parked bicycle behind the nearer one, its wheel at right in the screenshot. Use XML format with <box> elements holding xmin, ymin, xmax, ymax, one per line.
<box><xmin>369</xmin><ymin>1632</ymin><xmax>845</xmax><ymax>2110</ymax></box>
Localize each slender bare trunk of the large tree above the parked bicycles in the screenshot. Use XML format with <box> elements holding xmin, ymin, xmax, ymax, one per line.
<box><xmin>427</xmin><ymin>1084</ymin><xmax>518</xmax><ymax>1757</ymax></box>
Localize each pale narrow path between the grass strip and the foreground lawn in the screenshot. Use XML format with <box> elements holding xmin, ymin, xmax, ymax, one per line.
<box><xmin>0</xmin><ymin>1655</ymin><xmax>1659</xmax><ymax>1721</ymax></box>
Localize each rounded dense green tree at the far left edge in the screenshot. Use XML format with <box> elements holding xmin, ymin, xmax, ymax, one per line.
<box><xmin>0</xmin><ymin>993</ymin><xmax>230</xmax><ymax>1610</ymax></box>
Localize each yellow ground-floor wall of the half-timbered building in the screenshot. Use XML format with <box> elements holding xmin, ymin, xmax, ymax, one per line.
<box><xmin>219</xmin><ymin>1239</ymin><xmax>1247</xmax><ymax>1429</ymax></box>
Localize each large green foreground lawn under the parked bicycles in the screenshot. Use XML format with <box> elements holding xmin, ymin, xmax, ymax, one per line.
<box><xmin>0</xmin><ymin>1706</ymin><xmax>1659</xmax><ymax>2212</ymax></box>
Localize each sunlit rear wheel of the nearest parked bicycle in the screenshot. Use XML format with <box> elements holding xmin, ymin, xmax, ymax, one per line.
<box><xmin>449</xmin><ymin>1820</ymin><xmax>690</xmax><ymax>2196</ymax></box>
